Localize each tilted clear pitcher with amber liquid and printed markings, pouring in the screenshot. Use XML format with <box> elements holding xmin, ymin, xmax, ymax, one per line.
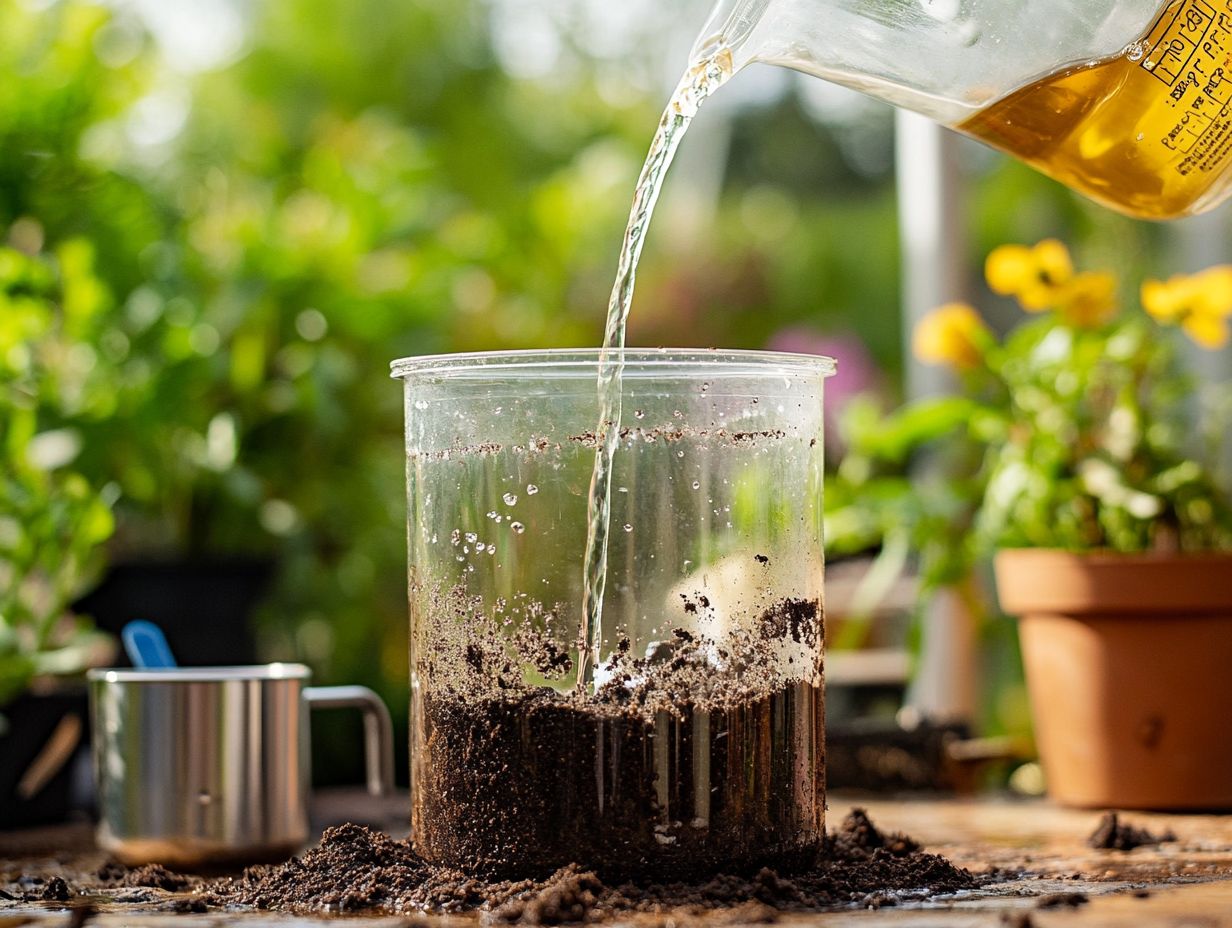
<box><xmin>694</xmin><ymin>0</ymin><xmax>1232</xmax><ymax>219</ymax></box>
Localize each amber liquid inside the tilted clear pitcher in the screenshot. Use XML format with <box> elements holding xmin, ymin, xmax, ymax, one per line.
<box><xmin>957</xmin><ymin>0</ymin><xmax>1232</xmax><ymax>219</ymax></box>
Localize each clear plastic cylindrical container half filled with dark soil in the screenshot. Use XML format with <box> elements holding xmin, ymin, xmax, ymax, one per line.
<box><xmin>393</xmin><ymin>350</ymin><xmax>834</xmax><ymax>877</ymax></box>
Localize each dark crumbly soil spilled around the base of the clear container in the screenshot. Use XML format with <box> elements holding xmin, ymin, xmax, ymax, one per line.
<box><xmin>202</xmin><ymin>810</ymin><xmax>977</xmax><ymax>924</ymax></box>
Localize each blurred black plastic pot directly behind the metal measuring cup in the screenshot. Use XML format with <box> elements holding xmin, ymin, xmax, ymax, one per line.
<box><xmin>74</xmin><ymin>560</ymin><xmax>274</xmax><ymax>667</ymax></box>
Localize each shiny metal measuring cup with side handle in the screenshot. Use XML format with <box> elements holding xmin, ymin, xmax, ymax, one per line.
<box><xmin>89</xmin><ymin>663</ymin><xmax>393</xmax><ymax>869</ymax></box>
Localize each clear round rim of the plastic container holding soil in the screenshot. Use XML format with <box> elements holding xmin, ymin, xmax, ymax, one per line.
<box><xmin>389</xmin><ymin>348</ymin><xmax>837</xmax><ymax>378</ymax></box>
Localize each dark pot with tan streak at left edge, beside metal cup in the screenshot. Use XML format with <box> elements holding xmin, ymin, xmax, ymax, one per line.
<box><xmin>0</xmin><ymin>686</ymin><xmax>90</xmax><ymax>831</ymax></box>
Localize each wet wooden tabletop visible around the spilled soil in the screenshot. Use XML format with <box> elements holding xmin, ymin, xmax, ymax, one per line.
<box><xmin>0</xmin><ymin>796</ymin><xmax>1232</xmax><ymax>928</ymax></box>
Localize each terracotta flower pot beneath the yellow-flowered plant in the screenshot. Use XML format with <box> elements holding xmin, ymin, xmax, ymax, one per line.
<box><xmin>995</xmin><ymin>550</ymin><xmax>1232</xmax><ymax>810</ymax></box>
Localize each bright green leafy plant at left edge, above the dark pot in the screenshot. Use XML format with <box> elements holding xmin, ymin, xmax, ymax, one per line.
<box><xmin>0</xmin><ymin>242</ymin><xmax>113</xmax><ymax>706</ymax></box>
